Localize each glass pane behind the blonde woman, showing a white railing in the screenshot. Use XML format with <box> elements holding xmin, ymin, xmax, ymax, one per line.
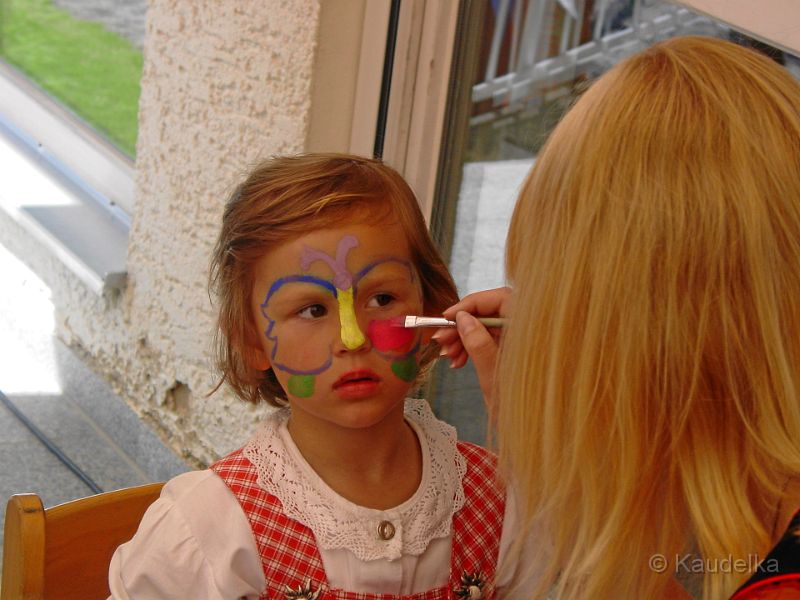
<box><xmin>433</xmin><ymin>0</ymin><xmax>800</xmax><ymax>443</ymax></box>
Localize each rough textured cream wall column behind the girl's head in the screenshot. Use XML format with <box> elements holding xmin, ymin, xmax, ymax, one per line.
<box><xmin>55</xmin><ymin>0</ymin><xmax>319</xmax><ymax>462</ymax></box>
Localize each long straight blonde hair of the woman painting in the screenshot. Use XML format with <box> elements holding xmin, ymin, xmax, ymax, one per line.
<box><xmin>498</xmin><ymin>37</ymin><xmax>800</xmax><ymax>599</ymax></box>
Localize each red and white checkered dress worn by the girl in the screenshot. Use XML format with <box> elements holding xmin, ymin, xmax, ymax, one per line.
<box><xmin>211</xmin><ymin>442</ymin><xmax>505</xmax><ymax>600</ymax></box>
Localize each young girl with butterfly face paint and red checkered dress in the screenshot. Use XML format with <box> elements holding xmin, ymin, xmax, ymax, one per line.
<box><xmin>110</xmin><ymin>155</ymin><xmax>528</xmax><ymax>600</ymax></box>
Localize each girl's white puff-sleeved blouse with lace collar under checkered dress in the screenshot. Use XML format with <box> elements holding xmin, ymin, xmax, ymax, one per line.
<box><xmin>109</xmin><ymin>400</ymin><xmax>532</xmax><ymax>600</ymax></box>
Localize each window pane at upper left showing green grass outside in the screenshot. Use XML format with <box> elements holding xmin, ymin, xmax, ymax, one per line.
<box><xmin>0</xmin><ymin>0</ymin><xmax>146</xmax><ymax>213</ymax></box>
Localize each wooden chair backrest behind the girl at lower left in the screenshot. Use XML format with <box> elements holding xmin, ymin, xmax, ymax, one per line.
<box><xmin>0</xmin><ymin>483</ymin><xmax>164</xmax><ymax>600</ymax></box>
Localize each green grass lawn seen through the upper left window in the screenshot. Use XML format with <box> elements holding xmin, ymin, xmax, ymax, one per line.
<box><xmin>0</xmin><ymin>0</ymin><xmax>142</xmax><ymax>156</ymax></box>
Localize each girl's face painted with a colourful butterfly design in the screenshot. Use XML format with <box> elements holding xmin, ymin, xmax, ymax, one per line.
<box><xmin>252</xmin><ymin>223</ymin><xmax>423</xmax><ymax>427</ymax></box>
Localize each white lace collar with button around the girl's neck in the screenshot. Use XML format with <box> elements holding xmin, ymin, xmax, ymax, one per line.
<box><xmin>243</xmin><ymin>400</ymin><xmax>467</xmax><ymax>561</ymax></box>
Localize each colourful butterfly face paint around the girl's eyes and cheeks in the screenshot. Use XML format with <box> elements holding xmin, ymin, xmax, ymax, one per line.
<box><xmin>260</xmin><ymin>232</ymin><xmax>422</xmax><ymax>400</ymax></box>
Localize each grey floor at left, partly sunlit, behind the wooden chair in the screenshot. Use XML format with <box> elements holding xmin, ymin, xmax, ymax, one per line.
<box><xmin>0</xmin><ymin>239</ymin><xmax>188</xmax><ymax>560</ymax></box>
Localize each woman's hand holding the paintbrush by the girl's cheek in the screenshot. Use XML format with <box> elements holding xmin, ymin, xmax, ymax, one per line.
<box><xmin>433</xmin><ymin>287</ymin><xmax>511</xmax><ymax>407</ymax></box>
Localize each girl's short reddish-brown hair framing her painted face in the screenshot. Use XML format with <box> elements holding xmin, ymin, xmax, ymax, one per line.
<box><xmin>209</xmin><ymin>153</ymin><xmax>458</xmax><ymax>406</ymax></box>
